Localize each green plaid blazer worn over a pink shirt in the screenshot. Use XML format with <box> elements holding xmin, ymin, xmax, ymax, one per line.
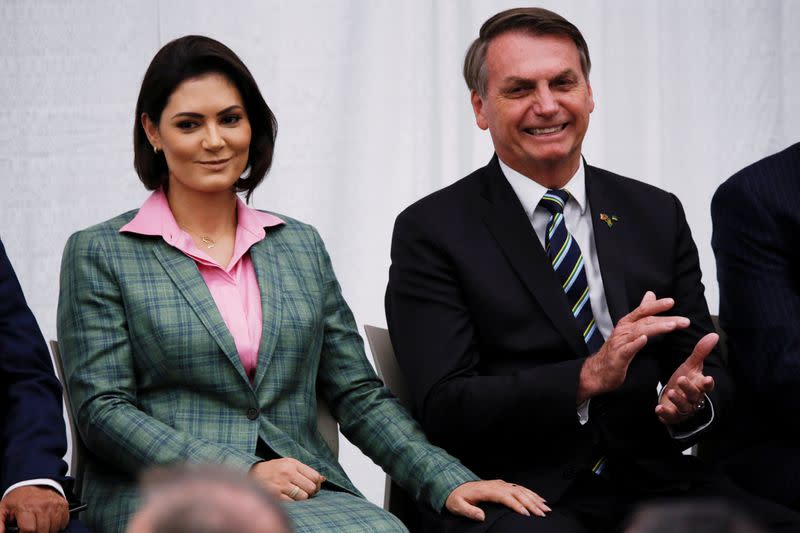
<box><xmin>58</xmin><ymin>211</ymin><xmax>477</xmax><ymax>533</ymax></box>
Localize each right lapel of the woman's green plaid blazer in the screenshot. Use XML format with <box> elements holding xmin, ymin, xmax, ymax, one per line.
<box><xmin>255</xmin><ymin>231</ymin><xmax>283</xmax><ymax>389</ymax></box>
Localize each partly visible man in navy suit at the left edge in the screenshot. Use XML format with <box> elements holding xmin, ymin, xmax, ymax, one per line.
<box><xmin>0</xmin><ymin>242</ymin><xmax>86</xmax><ymax>533</ymax></box>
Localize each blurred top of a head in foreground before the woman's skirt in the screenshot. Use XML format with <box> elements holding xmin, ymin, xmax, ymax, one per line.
<box><xmin>127</xmin><ymin>466</ymin><xmax>291</xmax><ymax>533</ymax></box>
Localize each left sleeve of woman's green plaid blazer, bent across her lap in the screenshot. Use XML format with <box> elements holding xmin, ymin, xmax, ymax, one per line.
<box><xmin>58</xmin><ymin>230</ymin><xmax>260</xmax><ymax>475</ymax></box>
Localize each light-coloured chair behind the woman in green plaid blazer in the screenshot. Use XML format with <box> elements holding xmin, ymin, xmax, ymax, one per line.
<box><xmin>50</xmin><ymin>340</ymin><xmax>339</xmax><ymax>495</ymax></box>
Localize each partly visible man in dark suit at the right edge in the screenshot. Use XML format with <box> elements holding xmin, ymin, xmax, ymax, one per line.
<box><xmin>711</xmin><ymin>143</ymin><xmax>800</xmax><ymax>510</ymax></box>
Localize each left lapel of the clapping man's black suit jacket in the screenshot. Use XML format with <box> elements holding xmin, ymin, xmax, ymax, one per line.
<box><xmin>477</xmin><ymin>156</ymin><xmax>588</xmax><ymax>355</ymax></box>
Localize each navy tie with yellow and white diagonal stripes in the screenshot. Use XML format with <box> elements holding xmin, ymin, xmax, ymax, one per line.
<box><xmin>539</xmin><ymin>190</ymin><xmax>603</xmax><ymax>354</ymax></box>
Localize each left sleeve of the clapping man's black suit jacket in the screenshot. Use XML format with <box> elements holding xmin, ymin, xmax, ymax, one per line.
<box><xmin>386</xmin><ymin>208</ymin><xmax>585</xmax><ymax>444</ymax></box>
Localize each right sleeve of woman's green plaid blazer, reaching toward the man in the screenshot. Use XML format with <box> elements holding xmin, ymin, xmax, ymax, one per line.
<box><xmin>314</xmin><ymin>231</ymin><xmax>478</xmax><ymax>511</ymax></box>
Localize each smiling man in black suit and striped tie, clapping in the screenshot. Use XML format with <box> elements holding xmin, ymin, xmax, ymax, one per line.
<box><xmin>386</xmin><ymin>8</ymin><xmax>797</xmax><ymax>533</ymax></box>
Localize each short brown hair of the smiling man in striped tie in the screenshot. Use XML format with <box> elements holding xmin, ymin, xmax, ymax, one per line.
<box><xmin>464</xmin><ymin>7</ymin><xmax>592</xmax><ymax>96</ymax></box>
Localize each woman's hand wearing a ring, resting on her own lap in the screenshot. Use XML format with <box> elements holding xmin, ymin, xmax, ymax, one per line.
<box><xmin>250</xmin><ymin>458</ymin><xmax>325</xmax><ymax>501</ymax></box>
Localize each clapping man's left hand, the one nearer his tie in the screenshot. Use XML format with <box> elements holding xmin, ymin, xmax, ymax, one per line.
<box><xmin>576</xmin><ymin>291</ymin><xmax>689</xmax><ymax>405</ymax></box>
